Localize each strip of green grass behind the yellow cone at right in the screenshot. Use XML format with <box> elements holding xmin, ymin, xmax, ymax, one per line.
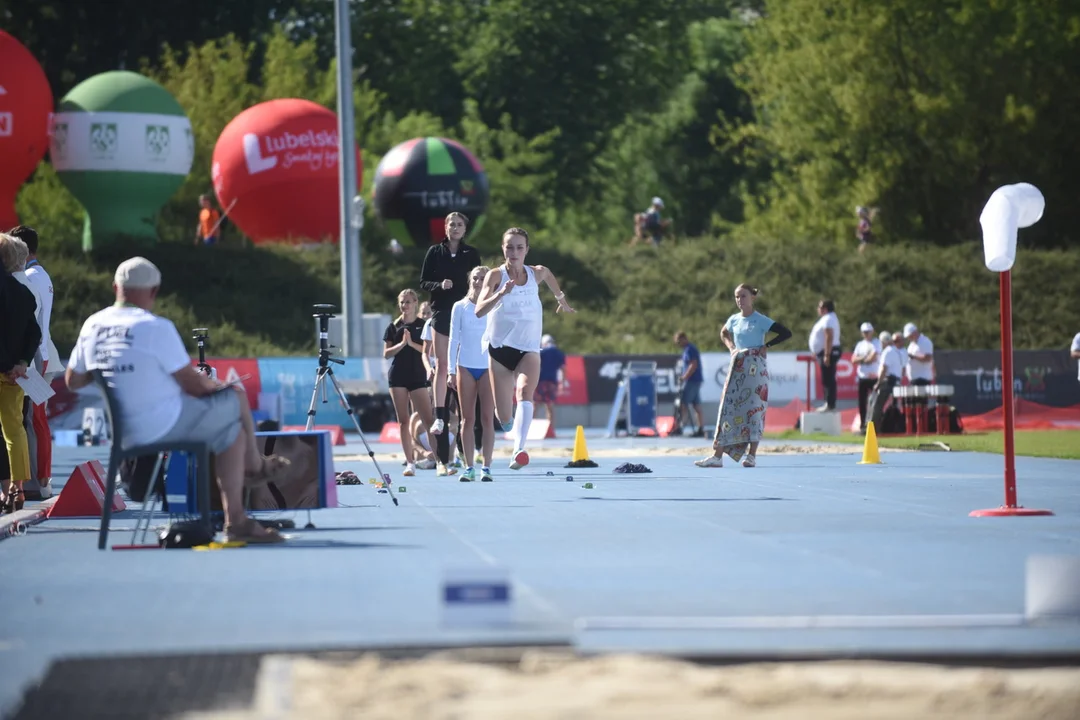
<box><xmin>766</xmin><ymin>430</ymin><xmax>1080</xmax><ymax>460</ymax></box>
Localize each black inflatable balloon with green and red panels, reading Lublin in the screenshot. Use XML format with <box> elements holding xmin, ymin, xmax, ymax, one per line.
<box><xmin>374</xmin><ymin>137</ymin><xmax>488</xmax><ymax>247</ymax></box>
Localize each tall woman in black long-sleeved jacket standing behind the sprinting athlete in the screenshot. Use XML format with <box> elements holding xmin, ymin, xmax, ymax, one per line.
<box><xmin>420</xmin><ymin>213</ymin><xmax>481</xmax><ymax>464</ymax></box>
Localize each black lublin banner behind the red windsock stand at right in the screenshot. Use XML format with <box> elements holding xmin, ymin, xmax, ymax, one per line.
<box><xmin>934</xmin><ymin>350</ymin><xmax>1080</xmax><ymax>415</ymax></box>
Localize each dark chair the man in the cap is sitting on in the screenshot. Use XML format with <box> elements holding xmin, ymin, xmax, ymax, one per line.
<box><xmin>92</xmin><ymin>370</ymin><xmax>213</xmax><ymax>549</ymax></box>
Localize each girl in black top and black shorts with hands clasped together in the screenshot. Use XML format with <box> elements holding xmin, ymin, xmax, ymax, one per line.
<box><xmin>382</xmin><ymin>289</ymin><xmax>434</xmax><ymax>476</ymax></box>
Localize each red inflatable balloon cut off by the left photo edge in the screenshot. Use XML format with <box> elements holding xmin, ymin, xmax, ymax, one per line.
<box><xmin>0</xmin><ymin>30</ymin><xmax>53</xmax><ymax>231</ymax></box>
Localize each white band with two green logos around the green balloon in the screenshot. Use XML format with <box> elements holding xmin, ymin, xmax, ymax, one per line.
<box><xmin>50</xmin><ymin>112</ymin><xmax>195</xmax><ymax>175</ymax></box>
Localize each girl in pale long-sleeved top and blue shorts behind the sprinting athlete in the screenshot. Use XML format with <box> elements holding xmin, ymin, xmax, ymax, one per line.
<box><xmin>447</xmin><ymin>266</ymin><xmax>495</xmax><ymax>483</ymax></box>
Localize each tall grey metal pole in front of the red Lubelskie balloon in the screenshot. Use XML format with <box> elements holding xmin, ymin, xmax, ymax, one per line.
<box><xmin>334</xmin><ymin>0</ymin><xmax>364</xmax><ymax>357</ymax></box>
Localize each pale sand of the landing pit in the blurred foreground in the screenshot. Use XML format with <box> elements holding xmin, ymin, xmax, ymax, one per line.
<box><xmin>188</xmin><ymin>651</ymin><xmax>1080</xmax><ymax>720</ymax></box>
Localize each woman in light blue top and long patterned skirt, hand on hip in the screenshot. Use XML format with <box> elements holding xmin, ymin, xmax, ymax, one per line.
<box><xmin>693</xmin><ymin>283</ymin><xmax>792</xmax><ymax>467</ymax></box>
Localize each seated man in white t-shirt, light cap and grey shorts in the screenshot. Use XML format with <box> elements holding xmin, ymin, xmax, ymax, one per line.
<box><xmin>65</xmin><ymin>258</ymin><xmax>288</xmax><ymax>543</ymax></box>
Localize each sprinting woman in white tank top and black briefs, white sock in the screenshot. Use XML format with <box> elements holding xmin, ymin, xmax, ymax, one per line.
<box><xmin>476</xmin><ymin>228</ymin><xmax>575</xmax><ymax>470</ymax></box>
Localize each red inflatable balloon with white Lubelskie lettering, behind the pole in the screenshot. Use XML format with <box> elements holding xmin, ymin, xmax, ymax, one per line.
<box><xmin>212</xmin><ymin>99</ymin><xmax>363</xmax><ymax>244</ymax></box>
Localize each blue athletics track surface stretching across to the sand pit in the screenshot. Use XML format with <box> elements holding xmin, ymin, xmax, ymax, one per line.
<box><xmin>0</xmin><ymin>431</ymin><xmax>1080</xmax><ymax>711</ymax></box>
